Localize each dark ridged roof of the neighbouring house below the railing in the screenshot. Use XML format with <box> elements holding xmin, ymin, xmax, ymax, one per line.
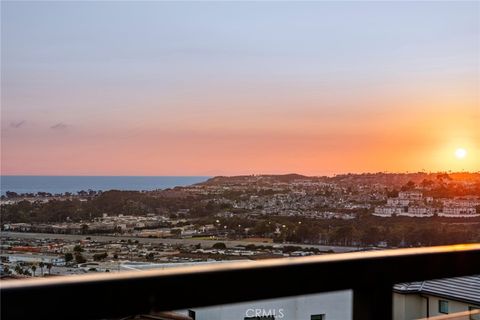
<box><xmin>393</xmin><ymin>275</ymin><xmax>480</xmax><ymax>305</ymax></box>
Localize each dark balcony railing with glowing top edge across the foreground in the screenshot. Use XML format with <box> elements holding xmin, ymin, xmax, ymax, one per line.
<box><xmin>0</xmin><ymin>244</ymin><xmax>480</xmax><ymax>320</ymax></box>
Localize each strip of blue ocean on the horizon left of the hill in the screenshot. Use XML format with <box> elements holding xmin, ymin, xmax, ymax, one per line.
<box><xmin>0</xmin><ymin>176</ymin><xmax>210</xmax><ymax>195</ymax></box>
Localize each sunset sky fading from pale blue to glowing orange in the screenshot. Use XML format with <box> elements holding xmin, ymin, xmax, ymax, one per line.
<box><xmin>1</xmin><ymin>1</ymin><xmax>480</xmax><ymax>175</ymax></box>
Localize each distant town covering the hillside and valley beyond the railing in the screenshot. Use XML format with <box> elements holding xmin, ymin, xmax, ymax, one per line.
<box><xmin>0</xmin><ymin>172</ymin><xmax>480</xmax><ymax>278</ymax></box>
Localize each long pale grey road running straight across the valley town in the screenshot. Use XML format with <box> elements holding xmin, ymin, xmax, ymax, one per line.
<box><xmin>1</xmin><ymin>231</ymin><xmax>359</xmax><ymax>253</ymax></box>
